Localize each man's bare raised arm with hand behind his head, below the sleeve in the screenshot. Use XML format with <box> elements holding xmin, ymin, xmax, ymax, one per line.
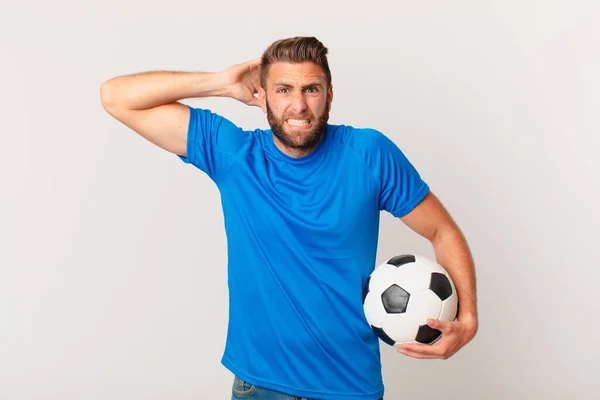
<box><xmin>100</xmin><ymin>59</ymin><xmax>260</xmax><ymax>156</ymax></box>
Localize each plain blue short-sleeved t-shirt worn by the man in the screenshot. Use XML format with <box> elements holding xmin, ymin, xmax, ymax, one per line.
<box><xmin>180</xmin><ymin>107</ymin><xmax>429</xmax><ymax>400</ymax></box>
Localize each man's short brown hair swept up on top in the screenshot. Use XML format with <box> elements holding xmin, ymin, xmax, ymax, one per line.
<box><xmin>260</xmin><ymin>36</ymin><xmax>331</xmax><ymax>88</ymax></box>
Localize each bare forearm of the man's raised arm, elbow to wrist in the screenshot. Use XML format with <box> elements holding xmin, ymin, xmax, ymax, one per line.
<box><xmin>101</xmin><ymin>71</ymin><xmax>228</xmax><ymax>110</ymax></box>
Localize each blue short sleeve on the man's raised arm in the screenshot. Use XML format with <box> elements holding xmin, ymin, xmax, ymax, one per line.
<box><xmin>179</xmin><ymin>106</ymin><xmax>242</xmax><ymax>182</ymax></box>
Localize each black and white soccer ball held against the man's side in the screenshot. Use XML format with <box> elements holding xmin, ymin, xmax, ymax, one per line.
<box><xmin>362</xmin><ymin>254</ymin><xmax>458</xmax><ymax>347</ymax></box>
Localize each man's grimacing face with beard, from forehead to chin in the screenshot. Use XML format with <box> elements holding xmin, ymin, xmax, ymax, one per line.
<box><xmin>261</xmin><ymin>62</ymin><xmax>333</xmax><ymax>153</ymax></box>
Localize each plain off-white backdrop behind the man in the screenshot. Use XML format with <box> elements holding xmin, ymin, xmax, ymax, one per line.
<box><xmin>0</xmin><ymin>0</ymin><xmax>600</xmax><ymax>400</ymax></box>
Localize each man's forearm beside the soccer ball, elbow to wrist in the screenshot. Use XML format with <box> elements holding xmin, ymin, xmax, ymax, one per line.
<box><xmin>432</xmin><ymin>228</ymin><xmax>478</xmax><ymax>330</ymax></box>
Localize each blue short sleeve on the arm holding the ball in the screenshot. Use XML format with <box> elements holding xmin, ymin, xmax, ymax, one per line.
<box><xmin>377</xmin><ymin>134</ymin><xmax>429</xmax><ymax>218</ymax></box>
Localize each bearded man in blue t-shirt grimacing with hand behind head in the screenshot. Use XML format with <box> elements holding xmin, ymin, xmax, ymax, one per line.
<box><xmin>101</xmin><ymin>37</ymin><xmax>478</xmax><ymax>400</ymax></box>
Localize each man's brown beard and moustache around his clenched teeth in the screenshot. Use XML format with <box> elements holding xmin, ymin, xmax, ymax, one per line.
<box><xmin>267</xmin><ymin>101</ymin><xmax>329</xmax><ymax>150</ymax></box>
